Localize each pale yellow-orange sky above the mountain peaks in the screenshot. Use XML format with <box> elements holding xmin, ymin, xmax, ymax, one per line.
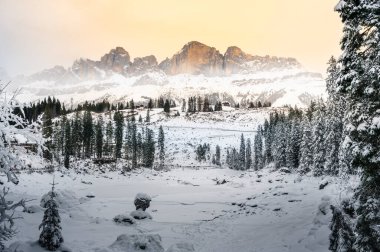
<box><xmin>0</xmin><ymin>0</ymin><xmax>342</xmax><ymax>75</ymax></box>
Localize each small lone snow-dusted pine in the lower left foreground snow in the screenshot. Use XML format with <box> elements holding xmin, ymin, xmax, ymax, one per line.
<box><xmin>39</xmin><ymin>181</ymin><xmax>63</xmax><ymax>251</ymax></box>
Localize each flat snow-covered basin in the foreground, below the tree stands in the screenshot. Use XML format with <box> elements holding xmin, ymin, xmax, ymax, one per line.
<box><xmin>7</xmin><ymin>166</ymin><xmax>354</xmax><ymax>252</ymax></box>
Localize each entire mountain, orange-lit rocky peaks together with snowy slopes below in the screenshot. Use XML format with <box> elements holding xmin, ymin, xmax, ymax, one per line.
<box><xmin>14</xmin><ymin>41</ymin><xmax>325</xmax><ymax>106</ymax></box>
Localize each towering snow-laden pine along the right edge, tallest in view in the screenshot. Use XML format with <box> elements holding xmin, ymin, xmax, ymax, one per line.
<box><xmin>336</xmin><ymin>0</ymin><xmax>380</xmax><ymax>252</ymax></box>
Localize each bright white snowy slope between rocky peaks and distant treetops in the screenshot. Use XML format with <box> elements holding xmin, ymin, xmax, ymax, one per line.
<box><xmin>14</xmin><ymin>68</ymin><xmax>326</xmax><ymax>107</ymax></box>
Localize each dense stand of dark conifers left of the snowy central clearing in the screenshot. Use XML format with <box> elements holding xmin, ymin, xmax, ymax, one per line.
<box><xmin>42</xmin><ymin>109</ymin><xmax>165</xmax><ymax>169</ymax></box>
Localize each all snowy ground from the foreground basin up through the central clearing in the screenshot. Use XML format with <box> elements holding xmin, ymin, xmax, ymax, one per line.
<box><xmin>8</xmin><ymin>108</ymin><xmax>355</xmax><ymax>252</ymax></box>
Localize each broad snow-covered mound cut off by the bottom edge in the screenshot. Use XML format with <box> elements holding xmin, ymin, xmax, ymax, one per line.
<box><xmin>110</xmin><ymin>234</ymin><xmax>164</xmax><ymax>252</ymax></box>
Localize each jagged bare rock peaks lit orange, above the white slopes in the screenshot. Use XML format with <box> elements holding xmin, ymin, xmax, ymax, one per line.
<box><xmin>20</xmin><ymin>41</ymin><xmax>301</xmax><ymax>84</ymax></box>
